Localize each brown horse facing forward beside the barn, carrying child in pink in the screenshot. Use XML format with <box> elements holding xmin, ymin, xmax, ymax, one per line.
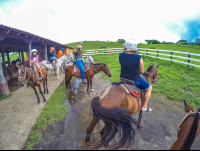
<box><xmin>16</xmin><ymin>63</ymin><xmax>49</xmax><ymax>105</ymax></box>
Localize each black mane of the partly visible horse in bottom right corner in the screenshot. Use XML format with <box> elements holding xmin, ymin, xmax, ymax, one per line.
<box><xmin>183</xmin><ymin>109</ymin><xmax>200</xmax><ymax>150</ymax></box>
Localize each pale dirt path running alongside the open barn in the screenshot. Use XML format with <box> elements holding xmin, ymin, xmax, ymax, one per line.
<box><xmin>0</xmin><ymin>71</ymin><xmax>64</xmax><ymax>150</ymax></box>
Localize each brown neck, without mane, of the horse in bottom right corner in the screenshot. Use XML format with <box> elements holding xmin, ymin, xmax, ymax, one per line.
<box><xmin>170</xmin><ymin>117</ymin><xmax>199</xmax><ymax>150</ymax></box>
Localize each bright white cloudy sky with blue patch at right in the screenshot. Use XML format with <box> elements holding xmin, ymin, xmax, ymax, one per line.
<box><xmin>0</xmin><ymin>0</ymin><xmax>200</xmax><ymax>44</ymax></box>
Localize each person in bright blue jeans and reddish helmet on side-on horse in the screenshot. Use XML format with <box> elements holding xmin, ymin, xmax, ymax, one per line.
<box><xmin>73</xmin><ymin>45</ymin><xmax>86</xmax><ymax>84</ymax></box>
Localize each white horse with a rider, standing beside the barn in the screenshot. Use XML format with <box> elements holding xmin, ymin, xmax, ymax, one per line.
<box><xmin>40</xmin><ymin>55</ymin><xmax>66</xmax><ymax>79</ymax></box>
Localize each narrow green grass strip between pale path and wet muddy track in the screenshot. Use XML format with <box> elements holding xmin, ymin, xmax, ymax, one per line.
<box><xmin>25</xmin><ymin>80</ymin><xmax>68</xmax><ymax>150</ymax></box>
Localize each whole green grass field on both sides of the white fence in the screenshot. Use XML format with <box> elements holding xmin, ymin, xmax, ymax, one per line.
<box><xmin>67</xmin><ymin>41</ymin><xmax>200</xmax><ymax>107</ymax></box>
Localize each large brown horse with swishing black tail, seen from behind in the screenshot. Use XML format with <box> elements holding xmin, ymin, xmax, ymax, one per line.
<box><xmin>85</xmin><ymin>64</ymin><xmax>159</xmax><ymax>149</ymax></box>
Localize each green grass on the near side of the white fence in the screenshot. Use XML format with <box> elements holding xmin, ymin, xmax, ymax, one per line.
<box><xmin>93</xmin><ymin>54</ymin><xmax>200</xmax><ymax>107</ymax></box>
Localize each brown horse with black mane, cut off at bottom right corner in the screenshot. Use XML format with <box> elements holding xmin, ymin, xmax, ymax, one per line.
<box><xmin>170</xmin><ymin>100</ymin><xmax>200</xmax><ymax>150</ymax></box>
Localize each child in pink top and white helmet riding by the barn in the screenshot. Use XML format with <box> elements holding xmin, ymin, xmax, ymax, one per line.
<box><xmin>30</xmin><ymin>49</ymin><xmax>44</xmax><ymax>80</ymax></box>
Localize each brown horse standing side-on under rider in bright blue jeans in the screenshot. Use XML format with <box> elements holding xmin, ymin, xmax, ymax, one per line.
<box><xmin>65</xmin><ymin>63</ymin><xmax>112</xmax><ymax>94</ymax></box>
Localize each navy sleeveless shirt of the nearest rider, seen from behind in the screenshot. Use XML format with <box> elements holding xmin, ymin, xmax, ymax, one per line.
<box><xmin>119</xmin><ymin>52</ymin><xmax>142</xmax><ymax>81</ymax></box>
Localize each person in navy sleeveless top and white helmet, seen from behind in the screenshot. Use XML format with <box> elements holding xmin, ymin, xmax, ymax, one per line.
<box><xmin>119</xmin><ymin>40</ymin><xmax>152</xmax><ymax>111</ymax></box>
